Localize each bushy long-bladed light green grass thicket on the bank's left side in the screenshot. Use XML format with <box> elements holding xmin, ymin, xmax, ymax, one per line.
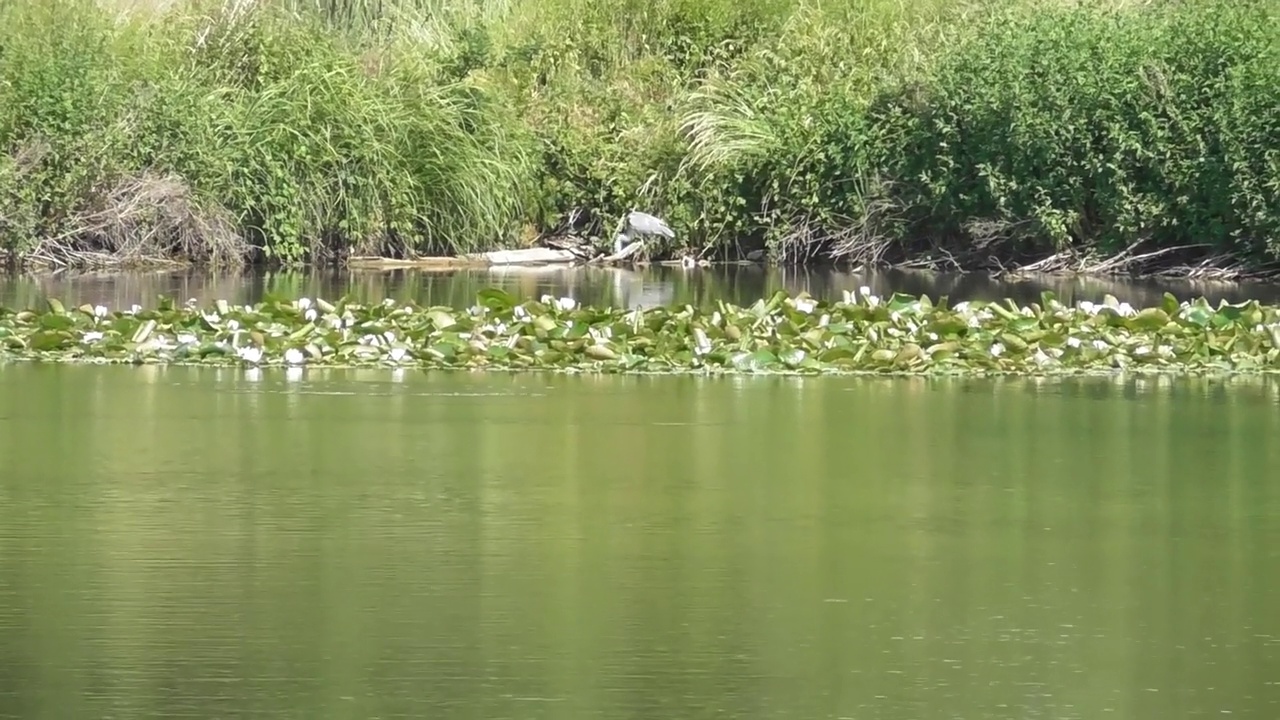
<box><xmin>0</xmin><ymin>0</ymin><xmax>531</xmax><ymax>261</ymax></box>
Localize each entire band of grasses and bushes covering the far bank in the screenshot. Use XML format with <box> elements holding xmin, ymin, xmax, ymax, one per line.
<box><xmin>0</xmin><ymin>0</ymin><xmax>1280</xmax><ymax>279</ymax></box>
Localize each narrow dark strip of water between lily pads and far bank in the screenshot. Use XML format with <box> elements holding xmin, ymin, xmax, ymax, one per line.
<box><xmin>0</xmin><ymin>265</ymin><xmax>1280</xmax><ymax>307</ymax></box>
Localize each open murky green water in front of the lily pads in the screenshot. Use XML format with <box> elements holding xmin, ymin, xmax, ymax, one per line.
<box><xmin>0</xmin><ymin>365</ymin><xmax>1280</xmax><ymax>720</ymax></box>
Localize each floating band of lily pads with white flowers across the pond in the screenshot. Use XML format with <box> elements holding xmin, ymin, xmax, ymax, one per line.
<box><xmin>0</xmin><ymin>288</ymin><xmax>1280</xmax><ymax>374</ymax></box>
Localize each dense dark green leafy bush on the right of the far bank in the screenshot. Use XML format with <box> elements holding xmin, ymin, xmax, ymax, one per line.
<box><xmin>874</xmin><ymin>1</ymin><xmax>1280</xmax><ymax>258</ymax></box>
